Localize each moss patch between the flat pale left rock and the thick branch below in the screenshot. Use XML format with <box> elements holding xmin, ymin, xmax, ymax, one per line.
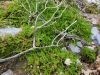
<box><xmin>0</xmin><ymin>25</ymin><xmax>33</xmax><ymax>57</ymax></box>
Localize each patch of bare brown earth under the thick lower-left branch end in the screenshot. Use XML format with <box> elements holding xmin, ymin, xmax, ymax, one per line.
<box><xmin>0</xmin><ymin>59</ymin><xmax>30</xmax><ymax>75</ymax></box>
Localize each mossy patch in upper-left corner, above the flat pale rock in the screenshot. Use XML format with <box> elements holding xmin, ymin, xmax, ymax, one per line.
<box><xmin>0</xmin><ymin>0</ymin><xmax>28</xmax><ymax>27</ymax></box>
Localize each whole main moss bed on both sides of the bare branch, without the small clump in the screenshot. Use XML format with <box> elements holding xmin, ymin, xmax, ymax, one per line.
<box><xmin>0</xmin><ymin>0</ymin><xmax>91</xmax><ymax>75</ymax></box>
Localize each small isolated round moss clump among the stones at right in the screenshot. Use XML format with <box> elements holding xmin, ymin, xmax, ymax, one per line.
<box><xmin>81</xmin><ymin>47</ymin><xmax>96</xmax><ymax>63</ymax></box>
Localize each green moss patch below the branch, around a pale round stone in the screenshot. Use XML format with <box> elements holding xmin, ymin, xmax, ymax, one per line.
<box><xmin>23</xmin><ymin>47</ymin><xmax>82</xmax><ymax>75</ymax></box>
